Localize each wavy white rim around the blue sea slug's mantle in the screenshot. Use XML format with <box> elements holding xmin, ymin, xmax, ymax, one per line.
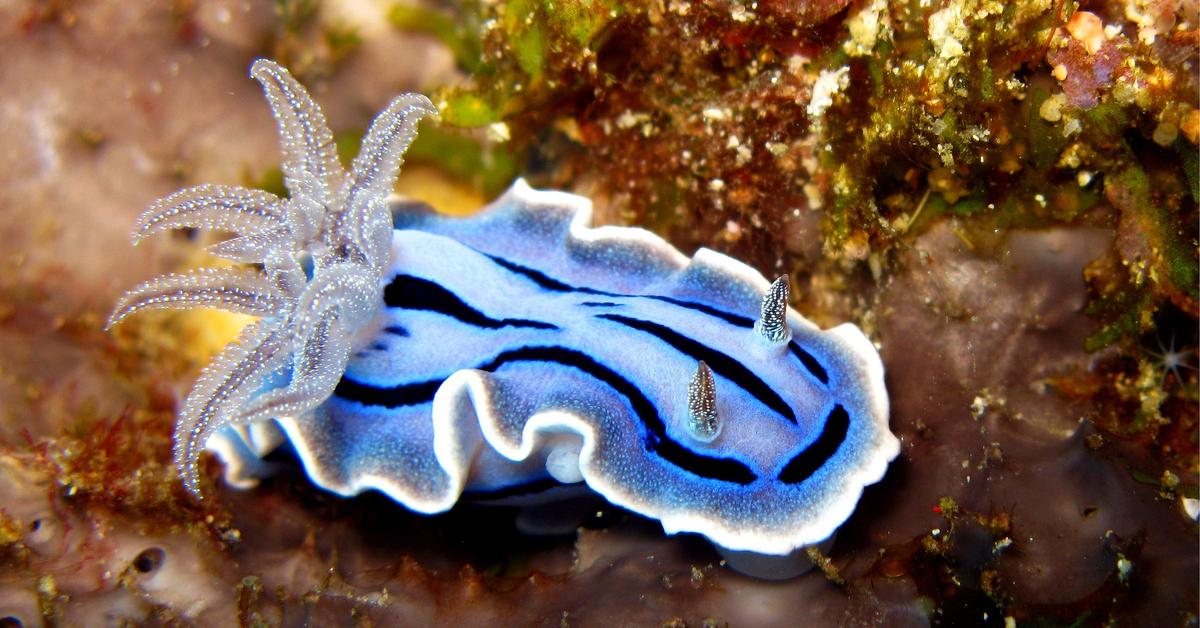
<box><xmin>209</xmin><ymin>180</ymin><xmax>900</xmax><ymax>555</ymax></box>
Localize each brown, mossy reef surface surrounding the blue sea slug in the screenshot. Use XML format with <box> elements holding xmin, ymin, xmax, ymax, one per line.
<box><xmin>0</xmin><ymin>0</ymin><xmax>1200</xmax><ymax>626</ymax></box>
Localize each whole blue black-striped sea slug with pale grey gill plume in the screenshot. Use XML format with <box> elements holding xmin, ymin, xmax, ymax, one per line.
<box><xmin>110</xmin><ymin>60</ymin><xmax>899</xmax><ymax>555</ymax></box>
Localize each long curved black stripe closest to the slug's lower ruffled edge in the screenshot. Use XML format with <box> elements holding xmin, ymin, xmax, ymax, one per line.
<box><xmin>335</xmin><ymin>346</ymin><xmax>758</xmax><ymax>484</ymax></box>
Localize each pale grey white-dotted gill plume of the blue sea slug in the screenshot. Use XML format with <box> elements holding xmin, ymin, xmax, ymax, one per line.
<box><xmin>109</xmin><ymin>59</ymin><xmax>437</xmax><ymax>495</ymax></box>
